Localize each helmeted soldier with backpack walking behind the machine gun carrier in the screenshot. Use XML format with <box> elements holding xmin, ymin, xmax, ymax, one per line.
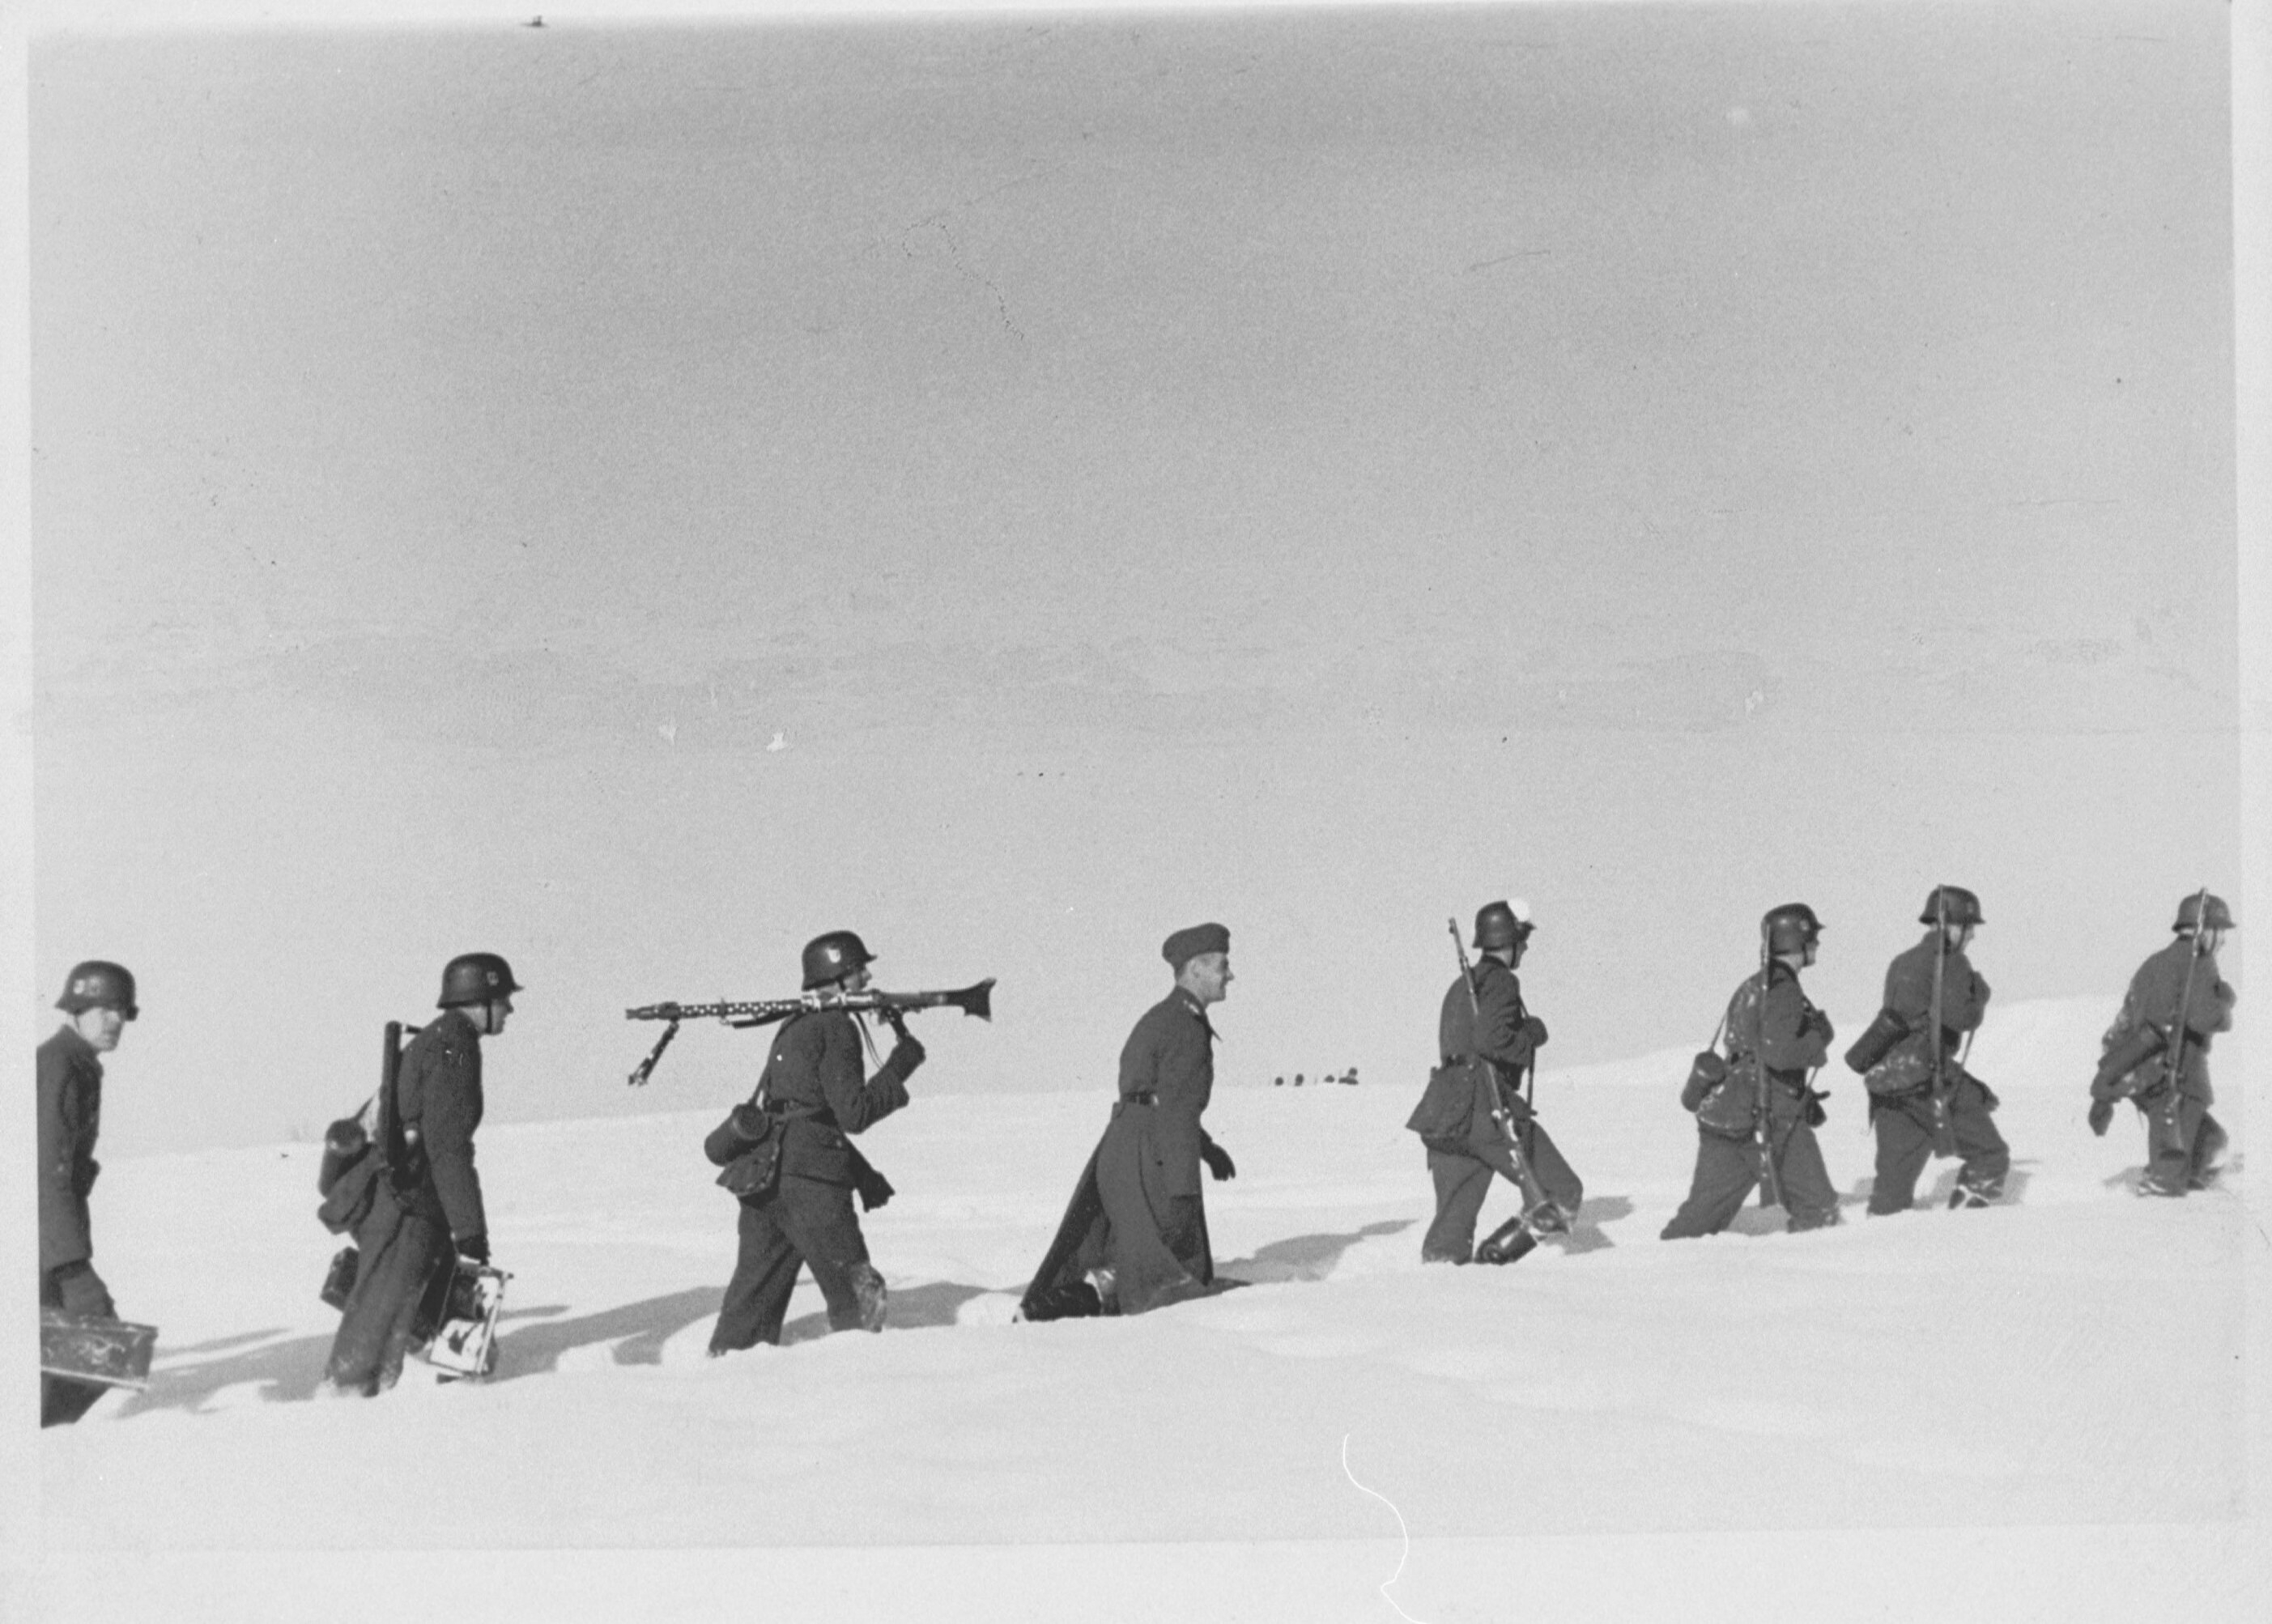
<box><xmin>322</xmin><ymin>954</ymin><xmax>522</xmax><ymax>1397</ymax></box>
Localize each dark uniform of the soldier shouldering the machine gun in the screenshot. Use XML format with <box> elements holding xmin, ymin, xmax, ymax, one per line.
<box><xmin>708</xmin><ymin>1009</ymin><xmax>922</xmax><ymax>1354</ymax></box>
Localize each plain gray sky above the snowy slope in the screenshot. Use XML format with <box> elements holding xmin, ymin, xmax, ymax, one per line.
<box><xmin>13</xmin><ymin>2</ymin><xmax>2247</xmax><ymax>1150</ymax></box>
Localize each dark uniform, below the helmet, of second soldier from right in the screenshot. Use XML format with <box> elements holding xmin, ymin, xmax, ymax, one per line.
<box><xmin>1863</xmin><ymin>927</ymin><xmax>2010</xmax><ymax>1215</ymax></box>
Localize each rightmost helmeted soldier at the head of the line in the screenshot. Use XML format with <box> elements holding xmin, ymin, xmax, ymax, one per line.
<box><xmin>2091</xmin><ymin>891</ymin><xmax>2236</xmax><ymax>1195</ymax></box>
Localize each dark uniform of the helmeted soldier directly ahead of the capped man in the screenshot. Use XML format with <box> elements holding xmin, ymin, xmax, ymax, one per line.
<box><xmin>1420</xmin><ymin>956</ymin><xmax>1586</xmax><ymax>1263</ymax></box>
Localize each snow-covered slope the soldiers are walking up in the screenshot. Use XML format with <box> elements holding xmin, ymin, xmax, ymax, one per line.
<box><xmin>32</xmin><ymin>997</ymin><xmax>2267</xmax><ymax>1624</ymax></box>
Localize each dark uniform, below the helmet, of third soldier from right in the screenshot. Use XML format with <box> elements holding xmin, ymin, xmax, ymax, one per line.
<box><xmin>1658</xmin><ymin>959</ymin><xmax>1838</xmax><ymax>1240</ymax></box>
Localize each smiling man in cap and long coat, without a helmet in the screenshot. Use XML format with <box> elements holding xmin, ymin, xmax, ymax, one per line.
<box><xmin>1023</xmin><ymin>925</ymin><xmax>1238</xmax><ymax>1320</ymax></box>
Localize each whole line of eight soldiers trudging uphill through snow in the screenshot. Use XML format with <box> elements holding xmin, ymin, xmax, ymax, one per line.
<box><xmin>39</xmin><ymin>886</ymin><xmax>2233</xmax><ymax>1424</ymax></box>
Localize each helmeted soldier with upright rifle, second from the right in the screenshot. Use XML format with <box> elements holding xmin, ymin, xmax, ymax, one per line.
<box><xmin>1847</xmin><ymin>886</ymin><xmax>2010</xmax><ymax>1215</ymax></box>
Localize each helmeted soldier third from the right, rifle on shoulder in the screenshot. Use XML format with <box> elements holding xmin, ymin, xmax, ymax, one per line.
<box><xmin>1658</xmin><ymin>902</ymin><xmax>1838</xmax><ymax>1240</ymax></box>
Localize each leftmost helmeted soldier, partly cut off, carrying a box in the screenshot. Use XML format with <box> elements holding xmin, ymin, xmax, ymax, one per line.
<box><xmin>36</xmin><ymin>959</ymin><xmax>141</xmax><ymax>1426</ymax></box>
